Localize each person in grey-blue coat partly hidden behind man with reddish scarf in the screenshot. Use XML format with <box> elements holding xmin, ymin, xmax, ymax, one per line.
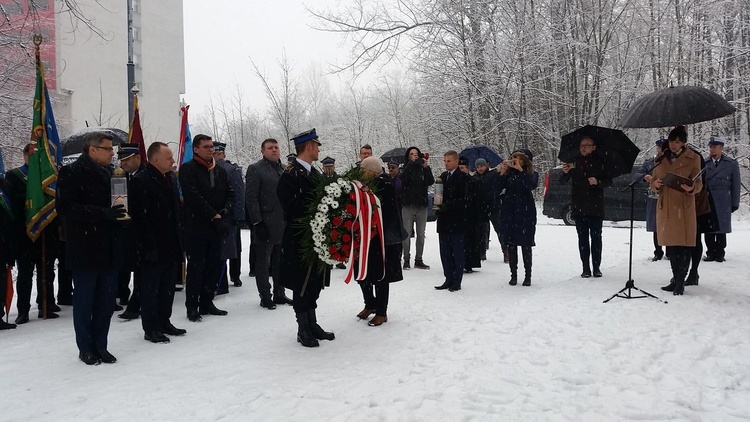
<box><xmin>214</xmin><ymin>142</ymin><xmax>245</xmax><ymax>294</ymax></box>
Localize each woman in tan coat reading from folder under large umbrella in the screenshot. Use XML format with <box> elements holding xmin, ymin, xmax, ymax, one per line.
<box><xmin>650</xmin><ymin>126</ymin><xmax>703</xmax><ymax>295</ymax></box>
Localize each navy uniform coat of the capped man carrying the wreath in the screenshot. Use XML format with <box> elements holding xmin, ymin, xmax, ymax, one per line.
<box><xmin>276</xmin><ymin>160</ymin><xmax>331</xmax><ymax>290</ymax></box>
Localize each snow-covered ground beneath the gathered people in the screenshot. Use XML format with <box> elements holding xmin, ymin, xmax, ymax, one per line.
<box><xmin>0</xmin><ymin>209</ymin><xmax>750</xmax><ymax>422</ymax></box>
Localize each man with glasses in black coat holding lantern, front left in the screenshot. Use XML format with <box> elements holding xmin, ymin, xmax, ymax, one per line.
<box><xmin>56</xmin><ymin>132</ymin><xmax>125</xmax><ymax>365</ymax></box>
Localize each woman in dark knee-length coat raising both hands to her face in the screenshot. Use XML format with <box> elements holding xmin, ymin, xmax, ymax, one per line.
<box><xmin>497</xmin><ymin>149</ymin><xmax>539</xmax><ymax>286</ymax></box>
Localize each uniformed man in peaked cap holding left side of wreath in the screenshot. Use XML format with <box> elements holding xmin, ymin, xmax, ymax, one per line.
<box><xmin>278</xmin><ymin>129</ymin><xmax>334</xmax><ymax>347</ymax></box>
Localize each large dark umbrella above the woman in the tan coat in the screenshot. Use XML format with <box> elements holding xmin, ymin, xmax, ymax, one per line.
<box><xmin>620</xmin><ymin>86</ymin><xmax>736</xmax><ymax>128</ymax></box>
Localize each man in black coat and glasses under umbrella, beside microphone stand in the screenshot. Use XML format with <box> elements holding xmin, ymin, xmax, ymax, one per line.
<box><xmin>560</xmin><ymin>138</ymin><xmax>612</xmax><ymax>278</ymax></box>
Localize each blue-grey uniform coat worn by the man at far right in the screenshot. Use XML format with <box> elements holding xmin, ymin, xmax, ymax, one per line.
<box><xmin>706</xmin><ymin>154</ymin><xmax>740</xmax><ymax>233</ymax></box>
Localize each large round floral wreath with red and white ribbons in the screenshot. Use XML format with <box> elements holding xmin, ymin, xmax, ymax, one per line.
<box><xmin>300</xmin><ymin>168</ymin><xmax>385</xmax><ymax>283</ymax></box>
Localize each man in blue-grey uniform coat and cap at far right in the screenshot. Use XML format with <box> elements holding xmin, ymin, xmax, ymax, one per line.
<box><xmin>704</xmin><ymin>138</ymin><xmax>740</xmax><ymax>262</ymax></box>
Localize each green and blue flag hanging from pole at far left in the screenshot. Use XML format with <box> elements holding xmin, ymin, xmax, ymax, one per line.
<box><xmin>26</xmin><ymin>35</ymin><xmax>62</xmax><ymax>240</ymax></box>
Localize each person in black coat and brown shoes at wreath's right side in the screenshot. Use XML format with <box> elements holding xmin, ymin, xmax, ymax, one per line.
<box><xmin>357</xmin><ymin>157</ymin><xmax>408</xmax><ymax>327</ymax></box>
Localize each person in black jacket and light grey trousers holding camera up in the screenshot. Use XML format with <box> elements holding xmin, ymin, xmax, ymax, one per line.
<box><xmin>400</xmin><ymin>147</ymin><xmax>435</xmax><ymax>270</ymax></box>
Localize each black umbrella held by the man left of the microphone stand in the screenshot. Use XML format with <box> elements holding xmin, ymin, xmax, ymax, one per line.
<box><xmin>557</xmin><ymin>125</ymin><xmax>641</xmax><ymax>178</ymax></box>
